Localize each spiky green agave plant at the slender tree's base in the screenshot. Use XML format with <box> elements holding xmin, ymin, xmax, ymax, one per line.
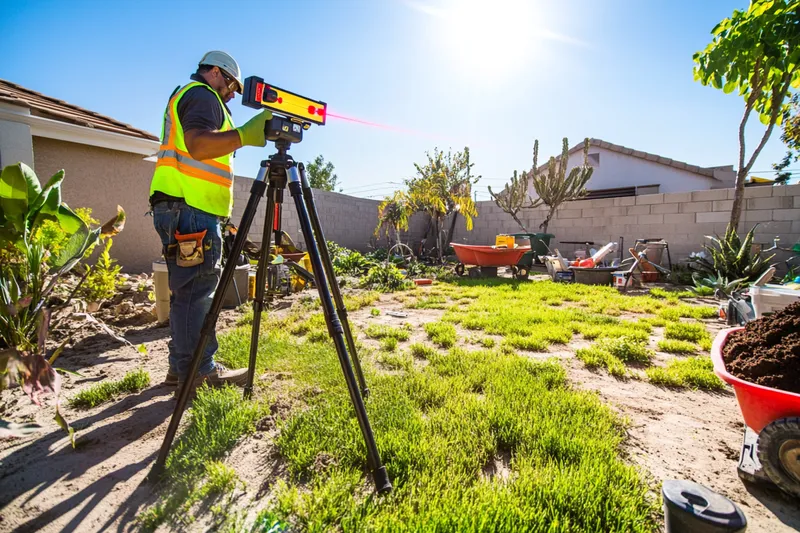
<box><xmin>693</xmin><ymin>224</ymin><xmax>775</xmax><ymax>292</ymax></box>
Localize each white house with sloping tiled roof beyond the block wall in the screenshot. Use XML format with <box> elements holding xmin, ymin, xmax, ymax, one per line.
<box><xmin>529</xmin><ymin>139</ymin><xmax>736</xmax><ymax>199</ymax></box>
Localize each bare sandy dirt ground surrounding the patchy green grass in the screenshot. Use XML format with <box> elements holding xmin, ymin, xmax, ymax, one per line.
<box><xmin>0</xmin><ymin>284</ymin><xmax>800</xmax><ymax>532</ymax></box>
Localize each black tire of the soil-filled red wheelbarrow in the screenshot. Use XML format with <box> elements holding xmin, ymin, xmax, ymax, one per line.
<box><xmin>758</xmin><ymin>417</ymin><xmax>800</xmax><ymax>498</ymax></box>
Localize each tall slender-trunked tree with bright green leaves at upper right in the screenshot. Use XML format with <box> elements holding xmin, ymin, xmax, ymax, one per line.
<box><xmin>693</xmin><ymin>0</ymin><xmax>800</xmax><ymax>227</ymax></box>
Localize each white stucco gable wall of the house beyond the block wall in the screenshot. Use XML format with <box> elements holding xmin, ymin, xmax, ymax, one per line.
<box><xmin>529</xmin><ymin>146</ymin><xmax>721</xmax><ymax>196</ymax></box>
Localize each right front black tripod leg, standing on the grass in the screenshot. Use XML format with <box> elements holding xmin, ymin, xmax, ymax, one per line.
<box><xmin>287</xmin><ymin>166</ymin><xmax>392</xmax><ymax>493</ymax></box>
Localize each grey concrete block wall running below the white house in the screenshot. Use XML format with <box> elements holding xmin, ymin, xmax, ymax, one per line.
<box><xmin>462</xmin><ymin>184</ymin><xmax>800</xmax><ymax>259</ymax></box>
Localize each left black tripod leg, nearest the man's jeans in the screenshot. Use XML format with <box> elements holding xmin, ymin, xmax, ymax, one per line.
<box><xmin>150</xmin><ymin>161</ymin><xmax>267</xmax><ymax>479</ymax></box>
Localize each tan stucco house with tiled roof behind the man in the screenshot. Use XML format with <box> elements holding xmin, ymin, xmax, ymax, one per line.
<box><xmin>0</xmin><ymin>79</ymin><xmax>161</xmax><ymax>272</ymax></box>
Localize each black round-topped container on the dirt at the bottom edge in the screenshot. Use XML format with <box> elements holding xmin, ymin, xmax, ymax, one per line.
<box><xmin>661</xmin><ymin>479</ymin><xmax>747</xmax><ymax>533</ymax></box>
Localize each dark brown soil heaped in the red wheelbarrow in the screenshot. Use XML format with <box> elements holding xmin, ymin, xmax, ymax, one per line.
<box><xmin>722</xmin><ymin>302</ymin><xmax>800</xmax><ymax>393</ymax></box>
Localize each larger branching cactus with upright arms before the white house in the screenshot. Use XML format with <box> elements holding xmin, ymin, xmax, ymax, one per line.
<box><xmin>526</xmin><ymin>137</ymin><xmax>594</xmax><ymax>233</ymax></box>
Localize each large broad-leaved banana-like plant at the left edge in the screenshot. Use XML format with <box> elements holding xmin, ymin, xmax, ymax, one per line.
<box><xmin>0</xmin><ymin>163</ymin><xmax>125</xmax><ymax>445</ymax></box>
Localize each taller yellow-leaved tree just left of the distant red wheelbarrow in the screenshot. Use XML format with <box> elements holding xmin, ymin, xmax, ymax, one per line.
<box><xmin>406</xmin><ymin>148</ymin><xmax>480</xmax><ymax>261</ymax></box>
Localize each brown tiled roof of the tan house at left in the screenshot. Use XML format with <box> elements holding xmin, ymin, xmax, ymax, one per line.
<box><xmin>0</xmin><ymin>79</ymin><xmax>159</xmax><ymax>141</ymax></box>
